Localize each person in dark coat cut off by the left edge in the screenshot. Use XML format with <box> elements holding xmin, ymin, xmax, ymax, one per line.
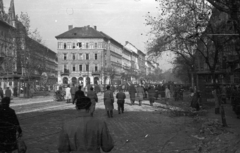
<box><xmin>0</xmin><ymin>97</ymin><xmax>22</xmax><ymax>153</ymax></box>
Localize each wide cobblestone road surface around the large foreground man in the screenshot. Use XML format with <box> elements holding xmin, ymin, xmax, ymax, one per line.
<box><xmin>15</xmin><ymin>92</ymin><xmax>199</xmax><ymax>153</ymax></box>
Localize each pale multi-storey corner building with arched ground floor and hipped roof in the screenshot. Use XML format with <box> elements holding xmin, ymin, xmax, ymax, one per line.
<box><xmin>56</xmin><ymin>26</ymin><xmax>122</xmax><ymax>86</ymax></box>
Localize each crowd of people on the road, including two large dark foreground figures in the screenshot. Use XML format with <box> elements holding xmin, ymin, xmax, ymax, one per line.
<box><xmin>0</xmin><ymin>84</ymin><xmax>186</xmax><ymax>153</ymax></box>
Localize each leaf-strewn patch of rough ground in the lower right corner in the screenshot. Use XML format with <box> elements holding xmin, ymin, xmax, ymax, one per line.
<box><xmin>191</xmin><ymin>117</ymin><xmax>240</xmax><ymax>153</ymax></box>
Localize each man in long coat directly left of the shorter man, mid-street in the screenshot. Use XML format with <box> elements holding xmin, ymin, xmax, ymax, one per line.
<box><xmin>103</xmin><ymin>85</ymin><xmax>114</xmax><ymax>118</ymax></box>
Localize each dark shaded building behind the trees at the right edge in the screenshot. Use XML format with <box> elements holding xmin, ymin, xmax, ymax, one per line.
<box><xmin>196</xmin><ymin>9</ymin><xmax>240</xmax><ymax>85</ymax></box>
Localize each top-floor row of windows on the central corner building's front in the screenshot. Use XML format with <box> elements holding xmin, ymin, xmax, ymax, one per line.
<box><xmin>58</xmin><ymin>42</ymin><xmax>106</xmax><ymax>49</ymax></box>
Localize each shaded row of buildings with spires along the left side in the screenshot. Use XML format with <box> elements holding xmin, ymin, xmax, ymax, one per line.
<box><xmin>0</xmin><ymin>0</ymin><xmax>57</xmax><ymax>95</ymax></box>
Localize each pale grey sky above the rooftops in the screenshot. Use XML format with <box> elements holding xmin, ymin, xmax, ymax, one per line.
<box><xmin>3</xmin><ymin>0</ymin><xmax>173</xmax><ymax>70</ymax></box>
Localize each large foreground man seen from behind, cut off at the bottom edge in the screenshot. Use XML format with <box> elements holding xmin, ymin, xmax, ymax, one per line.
<box><xmin>58</xmin><ymin>94</ymin><xmax>114</xmax><ymax>153</ymax></box>
